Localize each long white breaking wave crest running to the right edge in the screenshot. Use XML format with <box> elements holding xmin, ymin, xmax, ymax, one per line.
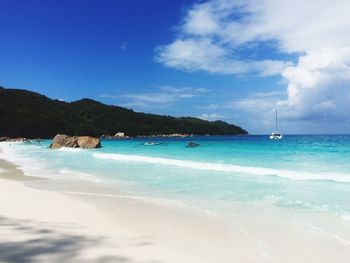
<box><xmin>93</xmin><ymin>153</ymin><xmax>350</xmax><ymax>183</ymax></box>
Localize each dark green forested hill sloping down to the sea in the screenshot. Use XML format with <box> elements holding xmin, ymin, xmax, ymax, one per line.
<box><xmin>0</xmin><ymin>87</ymin><xmax>247</xmax><ymax>138</ymax></box>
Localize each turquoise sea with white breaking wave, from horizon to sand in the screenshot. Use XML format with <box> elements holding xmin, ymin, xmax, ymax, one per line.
<box><xmin>1</xmin><ymin>135</ymin><xmax>350</xmax><ymax>218</ymax></box>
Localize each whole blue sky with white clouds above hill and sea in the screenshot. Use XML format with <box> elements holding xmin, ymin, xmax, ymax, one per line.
<box><xmin>0</xmin><ymin>0</ymin><xmax>350</xmax><ymax>134</ymax></box>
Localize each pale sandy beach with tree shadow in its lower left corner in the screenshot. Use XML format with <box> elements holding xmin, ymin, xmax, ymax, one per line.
<box><xmin>0</xmin><ymin>148</ymin><xmax>350</xmax><ymax>263</ymax></box>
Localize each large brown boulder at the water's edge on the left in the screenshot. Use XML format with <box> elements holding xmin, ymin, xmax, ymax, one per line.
<box><xmin>50</xmin><ymin>134</ymin><xmax>101</xmax><ymax>149</ymax></box>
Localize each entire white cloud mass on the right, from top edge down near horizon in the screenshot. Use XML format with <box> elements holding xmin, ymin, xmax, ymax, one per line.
<box><xmin>156</xmin><ymin>0</ymin><xmax>350</xmax><ymax>132</ymax></box>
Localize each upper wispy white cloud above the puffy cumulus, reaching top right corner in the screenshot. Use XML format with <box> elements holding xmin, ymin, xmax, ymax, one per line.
<box><xmin>157</xmin><ymin>0</ymin><xmax>350</xmax><ymax>75</ymax></box>
